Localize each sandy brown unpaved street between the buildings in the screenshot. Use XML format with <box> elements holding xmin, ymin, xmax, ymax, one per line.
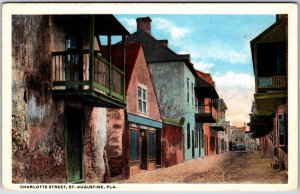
<box><xmin>115</xmin><ymin>152</ymin><xmax>288</xmax><ymax>184</ymax></box>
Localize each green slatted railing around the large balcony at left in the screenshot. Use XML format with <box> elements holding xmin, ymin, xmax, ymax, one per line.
<box><xmin>52</xmin><ymin>49</ymin><xmax>125</xmax><ymax>105</ymax></box>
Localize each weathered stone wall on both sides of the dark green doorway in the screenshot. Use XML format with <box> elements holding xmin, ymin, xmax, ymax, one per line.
<box><xmin>12</xmin><ymin>16</ymin><xmax>106</xmax><ymax>183</ymax></box>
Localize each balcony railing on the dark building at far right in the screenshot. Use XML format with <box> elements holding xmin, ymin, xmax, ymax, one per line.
<box><xmin>256</xmin><ymin>76</ymin><xmax>287</xmax><ymax>89</ymax></box>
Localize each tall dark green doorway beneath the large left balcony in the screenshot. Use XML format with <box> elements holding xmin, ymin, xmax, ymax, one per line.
<box><xmin>66</xmin><ymin>108</ymin><xmax>83</xmax><ymax>182</ymax></box>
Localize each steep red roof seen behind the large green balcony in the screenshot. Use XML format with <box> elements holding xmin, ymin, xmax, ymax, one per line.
<box><xmin>103</xmin><ymin>42</ymin><xmax>142</xmax><ymax>91</ymax></box>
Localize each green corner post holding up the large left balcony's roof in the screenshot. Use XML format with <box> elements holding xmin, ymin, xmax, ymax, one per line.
<box><xmin>89</xmin><ymin>15</ymin><xmax>95</xmax><ymax>90</ymax></box>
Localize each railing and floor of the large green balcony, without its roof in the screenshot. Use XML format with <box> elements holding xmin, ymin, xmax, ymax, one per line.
<box><xmin>52</xmin><ymin>49</ymin><xmax>126</xmax><ymax>108</ymax></box>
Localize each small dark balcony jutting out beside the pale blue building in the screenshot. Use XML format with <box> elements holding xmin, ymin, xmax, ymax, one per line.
<box><xmin>195</xmin><ymin>104</ymin><xmax>218</xmax><ymax>123</ymax></box>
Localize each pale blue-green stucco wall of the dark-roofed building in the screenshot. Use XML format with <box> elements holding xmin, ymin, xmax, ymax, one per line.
<box><xmin>149</xmin><ymin>62</ymin><xmax>201</xmax><ymax>160</ymax></box>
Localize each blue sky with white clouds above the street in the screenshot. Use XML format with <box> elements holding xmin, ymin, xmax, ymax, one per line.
<box><xmin>115</xmin><ymin>14</ymin><xmax>276</xmax><ymax>126</ymax></box>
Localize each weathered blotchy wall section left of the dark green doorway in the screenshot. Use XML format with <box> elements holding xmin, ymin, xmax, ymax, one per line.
<box><xmin>12</xmin><ymin>16</ymin><xmax>66</xmax><ymax>183</ymax></box>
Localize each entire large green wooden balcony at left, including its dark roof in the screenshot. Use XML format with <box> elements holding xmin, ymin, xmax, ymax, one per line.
<box><xmin>51</xmin><ymin>14</ymin><xmax>129</xmax><ymax>108</ymax></box>
